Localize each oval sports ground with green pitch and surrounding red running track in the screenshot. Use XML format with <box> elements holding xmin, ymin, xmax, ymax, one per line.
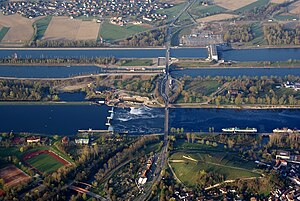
<box><xmin>23</xmin><ymin>150</ymin><xmax>70</xmax><ymax>174</ymax></box>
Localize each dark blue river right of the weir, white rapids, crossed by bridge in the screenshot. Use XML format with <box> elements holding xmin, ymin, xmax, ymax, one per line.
<box><xmin>112</xmin><ymin>107</ymin><xmax>300</xmax><ymax>134</ymax></box>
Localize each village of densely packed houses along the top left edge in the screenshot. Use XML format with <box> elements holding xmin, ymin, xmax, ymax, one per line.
<box><xmin>0</xmin><ymin>0</ymin><xmax>173</xmax><ymax>22</ymax></box>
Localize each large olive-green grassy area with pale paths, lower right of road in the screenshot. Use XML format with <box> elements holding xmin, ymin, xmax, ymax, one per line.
<box><xmin>170</xmin><ymin>143</ymin><xmax>260</xmax><ymax>186</ymax></box>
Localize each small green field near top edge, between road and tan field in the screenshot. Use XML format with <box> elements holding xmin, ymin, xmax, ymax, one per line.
<box><xmin>189</xmin><ymin>3</ymin><xmax>226</xmax><ymax>18</ymax></box>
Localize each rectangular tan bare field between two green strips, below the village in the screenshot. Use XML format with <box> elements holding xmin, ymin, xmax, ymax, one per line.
<box><xmin>42</xmin><ymin>17</ymin><xmax>100</xmax><ymax>41</ymax></box>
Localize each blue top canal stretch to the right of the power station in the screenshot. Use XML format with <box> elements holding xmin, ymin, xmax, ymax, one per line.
<box><xmin>220</xmin><ymin>48</ymin><xmax>300</xmax><ymax>61</ymax></box>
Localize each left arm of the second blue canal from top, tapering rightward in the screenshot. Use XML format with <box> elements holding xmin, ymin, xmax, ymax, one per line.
<box><xmin>0</xmin><ymin>66</ymin><xmax>102</xmax><ymax>78</ymax></box>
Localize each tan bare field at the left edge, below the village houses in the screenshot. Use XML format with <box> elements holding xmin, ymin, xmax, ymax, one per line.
<box><xmin>0</xmin><ymin>14</ymin><xmax>40</xmax><ymax>44</ymax></box>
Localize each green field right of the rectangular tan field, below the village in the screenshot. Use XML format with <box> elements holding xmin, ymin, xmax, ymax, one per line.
<box><xmin>99</xmin><ymin>22</ymin><xmax>149</xmax><ymax>41</ymax></box>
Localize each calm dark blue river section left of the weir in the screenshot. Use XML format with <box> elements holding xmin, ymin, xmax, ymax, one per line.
<box><xmin>0</xmin><ymin>104</ymin><xmax>109</xmax><ymax>135</ymax></box>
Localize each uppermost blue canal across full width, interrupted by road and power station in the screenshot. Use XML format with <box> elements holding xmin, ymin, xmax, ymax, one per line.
<box><xmin>0</xmin><ymin>48</ymin><xmax>300</xmax><ymax>61</ymax></box>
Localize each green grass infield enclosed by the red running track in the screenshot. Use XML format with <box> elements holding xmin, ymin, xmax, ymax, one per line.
<box><xmin>26</xmin><ymin>154</ymin><xmax>63</xmax><ymax>174</ymax></box>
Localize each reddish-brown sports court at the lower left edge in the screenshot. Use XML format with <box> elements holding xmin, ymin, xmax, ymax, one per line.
<box><xmin>0</xmin><ymin>165</ymin><xmax>30</xmax><ymax>187</ymax></box>
